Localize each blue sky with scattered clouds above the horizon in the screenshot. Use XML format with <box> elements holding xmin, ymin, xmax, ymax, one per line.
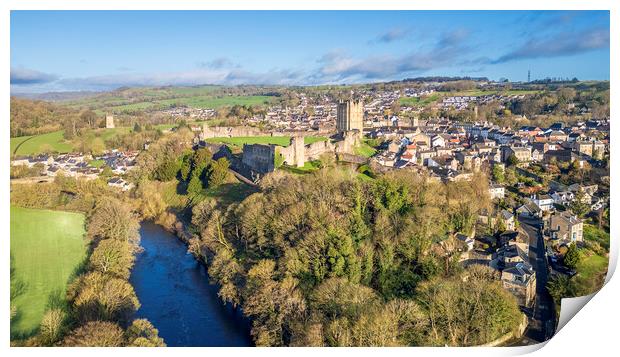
<box><xmin>11</xmin><ymin>11</ymin><xmax>610</xmax><ymax>93</ymax></box>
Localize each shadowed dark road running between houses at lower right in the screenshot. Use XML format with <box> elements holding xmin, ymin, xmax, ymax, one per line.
<box><xmin>519</xmin><ymin>217</ymin><xmax>555</xmax><ymax>342</ymax></box>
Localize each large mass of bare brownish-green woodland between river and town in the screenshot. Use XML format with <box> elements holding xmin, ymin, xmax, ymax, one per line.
<box><xmin>189</xmin><ymin>169</ymin><xmax>521</xmax><ymax>346</ymax></box>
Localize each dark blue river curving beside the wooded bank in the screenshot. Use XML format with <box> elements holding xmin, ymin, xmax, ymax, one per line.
<box><xmin>130</xmin><ymin>222</ymin><xmax>252</xmax><ymax>347</ymax></box>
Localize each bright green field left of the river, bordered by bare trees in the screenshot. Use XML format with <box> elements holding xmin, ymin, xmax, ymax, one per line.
<box><xmin>10</xmin><ymin>206</ymin><xmax>86</xmax><ymax>337</ymax></box>
